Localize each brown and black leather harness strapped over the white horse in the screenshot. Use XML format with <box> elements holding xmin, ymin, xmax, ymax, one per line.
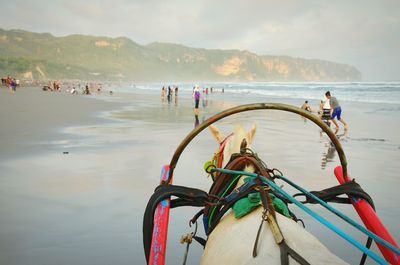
<box><xmin>143</xmin><ymin>148</ymin><xmax>384</xmax><ymax>265</ymax></box>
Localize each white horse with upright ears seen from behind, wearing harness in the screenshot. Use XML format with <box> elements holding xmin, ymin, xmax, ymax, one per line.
<box><xmin>201</xmin><ymin>126</ymin><xmax>346</xmax><ymax>264</ymax></box>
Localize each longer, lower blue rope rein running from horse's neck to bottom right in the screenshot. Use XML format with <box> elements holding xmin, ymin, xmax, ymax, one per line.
<box><xmin>213</xmin><ymin>168</ymin><xmax>389</xmax><ymax>264</ymax></box>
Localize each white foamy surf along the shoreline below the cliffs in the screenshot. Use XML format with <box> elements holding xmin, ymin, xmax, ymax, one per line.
<box><xmin>112</xmin><ymin>82</ymin><xmax>400</xmax><ymax>104</ymax></box>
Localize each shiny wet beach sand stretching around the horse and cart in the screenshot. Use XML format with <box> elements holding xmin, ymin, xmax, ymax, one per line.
<box><xmin>0</xmin><ymin>85</ymin><xmax>400</xmax><ymax>265</ymax></box>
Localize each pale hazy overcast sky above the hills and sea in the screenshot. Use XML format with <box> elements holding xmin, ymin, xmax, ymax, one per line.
<box><xmin>0</xmin><ymin>0</ymin><xmax>400</xmax><ymax>80</ymax></box>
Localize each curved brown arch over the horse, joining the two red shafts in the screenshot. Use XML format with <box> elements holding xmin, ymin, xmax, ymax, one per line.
<box><xmin>165</xmin><ymin>103</ymin><xmax>347</xmax><ymax>183</ymax></box>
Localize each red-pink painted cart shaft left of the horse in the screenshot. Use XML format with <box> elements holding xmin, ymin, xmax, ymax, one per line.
<box><xmin>149</xmin><ymin>165</ymin><xmax>172</xmax><ymax>265</ymax></box>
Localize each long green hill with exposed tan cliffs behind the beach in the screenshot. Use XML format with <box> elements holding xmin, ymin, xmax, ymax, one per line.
<box><xmin>0</xmin><ymin>29</ymin><xmax>361</xmax><ymax>81</ymax></box>
